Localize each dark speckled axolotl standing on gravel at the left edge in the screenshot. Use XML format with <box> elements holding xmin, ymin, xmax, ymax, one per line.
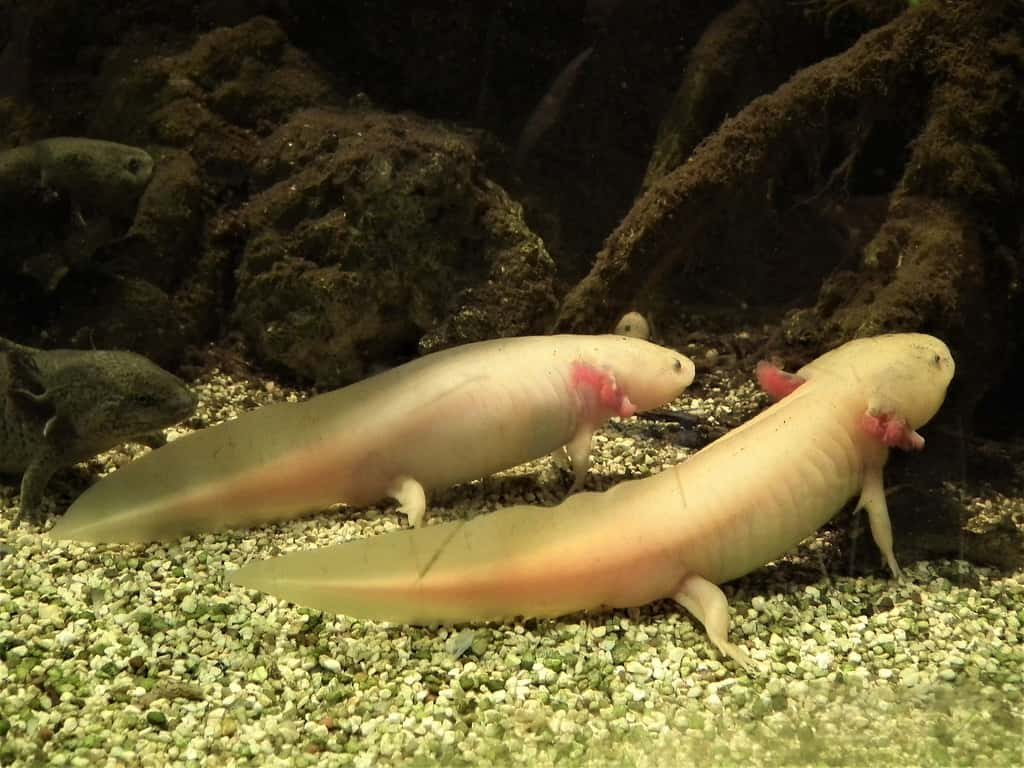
<box><xmin>0</xmin><ymin>338</ymin><xmax>196</xmax><ymax>519</ymax></box>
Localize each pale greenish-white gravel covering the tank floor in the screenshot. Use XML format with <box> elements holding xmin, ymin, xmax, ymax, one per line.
<box><xmin>0</xmin><ymin>373</ymin><xmax>1024</xmax><ymax>766</ymax></box>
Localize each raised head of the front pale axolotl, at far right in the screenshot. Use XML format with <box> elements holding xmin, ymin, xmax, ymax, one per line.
<box><xmin>797</xmin><ymin>333</ymin><xmax>955</xmax><ymax>429</ymax></box>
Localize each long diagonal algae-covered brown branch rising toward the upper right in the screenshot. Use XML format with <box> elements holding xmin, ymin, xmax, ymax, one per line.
<box><xmin>556</xmin><ymin>7</ymin><xmax>943</xmax><ymax>331</ymax></box>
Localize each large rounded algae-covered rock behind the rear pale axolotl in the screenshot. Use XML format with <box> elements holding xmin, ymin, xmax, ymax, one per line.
<box><xmin>232</xmin><ymin>110</ymin><xmax>555</xmax><ymax>386</ymax></box>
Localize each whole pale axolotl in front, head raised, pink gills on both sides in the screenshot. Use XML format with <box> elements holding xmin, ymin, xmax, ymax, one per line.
<box><xmin>229</xmin><ymin>334</ymin><xmax>953</xmax><ymax>666</ymax></box>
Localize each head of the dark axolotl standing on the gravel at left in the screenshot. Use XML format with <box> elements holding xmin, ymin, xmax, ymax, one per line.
<box><xmin>36</xmin><ymin>349</ymin><xmax>197</xmax><ymax>461</ymax></box>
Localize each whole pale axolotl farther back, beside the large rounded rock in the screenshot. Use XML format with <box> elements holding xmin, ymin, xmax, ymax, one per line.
<box><xmin>51</xmin><ymin>335</ymin><xmax>693</xmax><ymax>542</ymax></box>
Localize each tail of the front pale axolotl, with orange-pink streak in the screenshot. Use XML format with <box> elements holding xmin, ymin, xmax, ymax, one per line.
<box><xmin>229</xmin><ymin>483</ymin><xmax>680</xmax><ymax>625</ymax></box>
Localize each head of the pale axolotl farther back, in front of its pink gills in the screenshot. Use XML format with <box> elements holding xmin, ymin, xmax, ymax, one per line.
<box><xmin>583</xmin><ymin>334</ymin><xmax>694</xmax><ymax>416</ymax></box>
